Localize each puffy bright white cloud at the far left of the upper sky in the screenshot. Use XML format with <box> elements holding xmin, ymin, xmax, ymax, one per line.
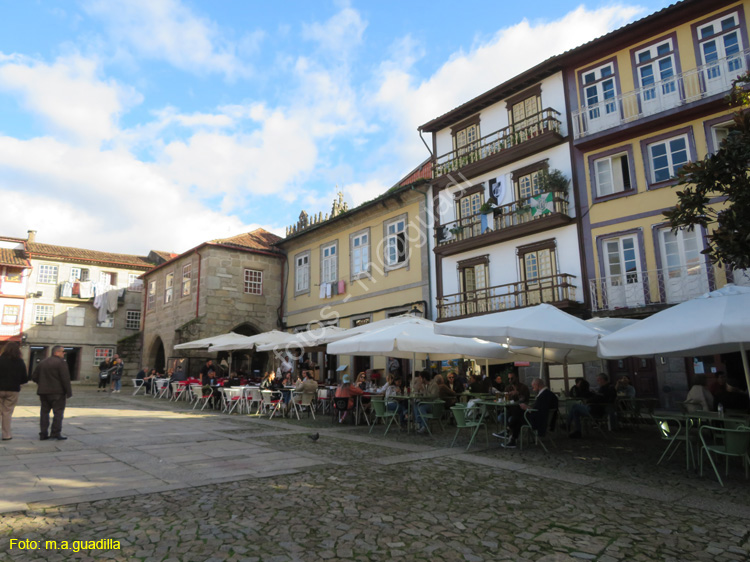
<box><xmin>0</xmin><ymin>55</ymin><xmax>142</xmax><ymax>143</ymax></box>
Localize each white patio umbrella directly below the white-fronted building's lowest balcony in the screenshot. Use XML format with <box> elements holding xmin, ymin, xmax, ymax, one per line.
<box><xmin>435</xmin><ymin>304</ymin><xmax>601</xmax><ymax>378</ymax></box>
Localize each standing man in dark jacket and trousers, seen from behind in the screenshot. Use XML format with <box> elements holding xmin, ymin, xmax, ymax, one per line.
<box><xmin>31</xmin><ymin>345</ymin><xmax>73</xmax><ymax>441</ymax></box>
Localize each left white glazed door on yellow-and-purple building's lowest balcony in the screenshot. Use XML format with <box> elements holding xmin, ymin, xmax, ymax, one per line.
<box><xmin>604</xmin><ymin>236</ymin><xmax>645</xmax><ymax>310</ymax></box>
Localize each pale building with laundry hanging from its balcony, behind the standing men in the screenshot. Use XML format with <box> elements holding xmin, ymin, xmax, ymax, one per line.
<box><xmin>19</xmin><ymin>230</ymin><xmax>154</xmax><ymax>383</ymax></box>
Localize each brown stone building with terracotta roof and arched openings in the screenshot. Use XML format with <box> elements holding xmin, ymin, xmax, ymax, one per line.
<box><xmin>142</xmin><ymin>228</ymin><xmax>286</xmax><ymax>373</ymax></box>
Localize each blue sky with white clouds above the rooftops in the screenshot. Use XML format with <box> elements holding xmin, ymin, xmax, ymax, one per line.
<box><xmin>0</xmin><ymin>0</ymin><xmax>669</xmax><ymax>255</ymax></box>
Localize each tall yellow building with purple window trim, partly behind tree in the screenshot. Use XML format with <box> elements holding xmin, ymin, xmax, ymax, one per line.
<box><xmin>567</xmin><ymin>0</ymin><xmax>750</xmax><ymax>395</ymax></box>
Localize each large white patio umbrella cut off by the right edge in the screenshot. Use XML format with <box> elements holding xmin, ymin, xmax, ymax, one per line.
<box><xmin>599</xmin><ymin>284</ymin><xmax>750</xmax><ymax>389</ymax></box>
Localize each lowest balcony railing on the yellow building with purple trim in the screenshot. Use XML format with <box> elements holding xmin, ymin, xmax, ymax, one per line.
<box><xmin>590</xmin><ymin>264</ymin><xmax>720</xmax><ymax>310</ymax></box>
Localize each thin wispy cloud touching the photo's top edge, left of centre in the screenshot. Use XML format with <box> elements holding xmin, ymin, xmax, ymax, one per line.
<box><xmin>85</xmin><ymin>0</ymin><xmax>253</xmax><ymax>79</ymax></box>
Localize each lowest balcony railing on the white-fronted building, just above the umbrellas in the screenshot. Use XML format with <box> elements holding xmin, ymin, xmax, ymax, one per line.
<box><xmin>437</xmin><ymin>273</ymin><xmax>576</xmax><ymax>319</ymax></box>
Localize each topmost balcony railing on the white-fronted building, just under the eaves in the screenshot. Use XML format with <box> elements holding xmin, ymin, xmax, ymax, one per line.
<box><xmin>432</xmin><ymin>108</ymin><xmax>561</xmax><ymax>178</ymax></box>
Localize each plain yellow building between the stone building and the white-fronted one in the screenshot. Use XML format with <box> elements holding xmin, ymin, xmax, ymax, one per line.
<box><xmin>277</xmin><ymin>163</ymin><xmax>430</xmax><ymax>378</ymax></box>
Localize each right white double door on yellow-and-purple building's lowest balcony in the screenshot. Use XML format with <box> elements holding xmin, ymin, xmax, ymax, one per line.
<box><xmin>659</xmin><ymin>228</ymin><xmax>708</xmax><ymax>304</ymax></box>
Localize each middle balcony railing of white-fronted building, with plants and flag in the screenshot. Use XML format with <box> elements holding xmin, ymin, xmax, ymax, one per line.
<box><xmin>435</xmin><ymin>191</ymin><xmax>568</xmax><ymax>246</ymax></box>
